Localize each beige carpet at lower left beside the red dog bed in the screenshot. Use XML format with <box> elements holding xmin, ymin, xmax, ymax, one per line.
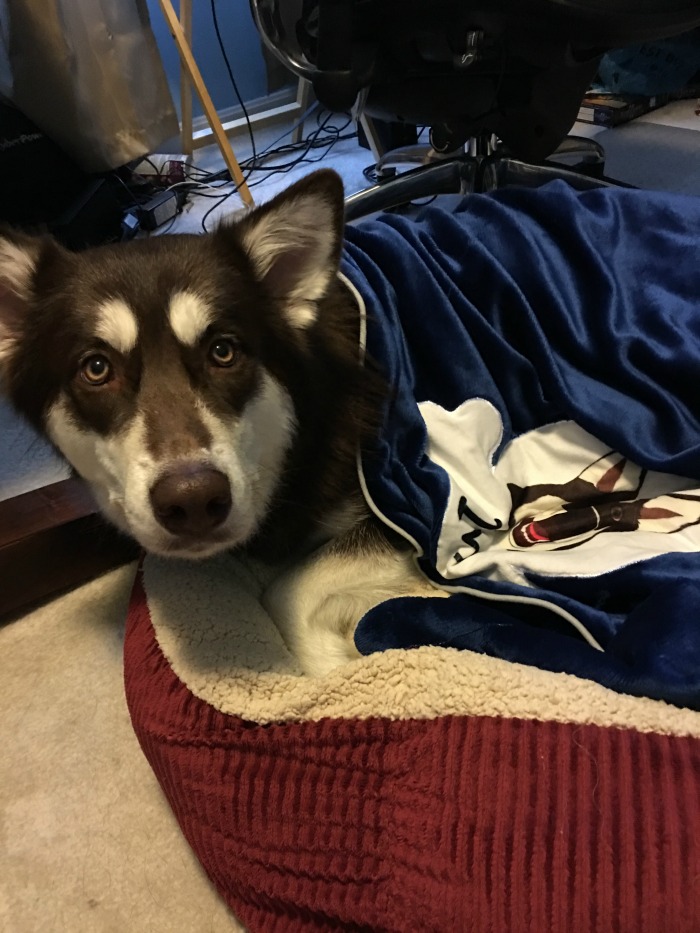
<box><xmin>0</xmin><ymin>567</ymin><xmax>242</xmax><ymax>933</ymax></box>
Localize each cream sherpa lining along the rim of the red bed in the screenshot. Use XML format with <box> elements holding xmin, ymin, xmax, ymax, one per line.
<box><xmin>143</xmin><ymin>556</ymin><xmax>700</xmax><ymax>737</ymax></box>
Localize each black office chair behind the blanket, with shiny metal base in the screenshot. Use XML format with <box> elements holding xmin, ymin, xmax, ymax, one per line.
<box><xmin>251</xmin><ymin>0</ymin><xmax>700</xmax><ymax>219</ymax></box>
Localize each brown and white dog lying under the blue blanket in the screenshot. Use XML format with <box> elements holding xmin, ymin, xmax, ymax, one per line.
<box><xmin>0</xmin><ymin>170</ymin><xmax>443</xmax><ymax>676</ymax></box>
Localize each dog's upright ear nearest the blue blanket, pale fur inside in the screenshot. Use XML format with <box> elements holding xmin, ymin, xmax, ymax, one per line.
<box><xmin>230</xmin><ymin>169</ymin><xmax>343</xmax><ymax>328</ymax></box>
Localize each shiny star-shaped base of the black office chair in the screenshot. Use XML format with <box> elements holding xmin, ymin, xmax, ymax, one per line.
<box><xmin>345</xmin><ymin>136</ymin><xmax>630</xmax><ymax>221</ymax></box>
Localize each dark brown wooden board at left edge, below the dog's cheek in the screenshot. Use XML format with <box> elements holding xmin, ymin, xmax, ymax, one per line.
<box><xmin>0</xmin><ymin>479</ymin><xmax>139</xmax><ymax>617</ymax></box>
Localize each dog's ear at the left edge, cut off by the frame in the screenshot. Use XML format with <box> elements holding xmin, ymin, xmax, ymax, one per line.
<box><xmin>0</xmin><ymin>229</ymin><xmax>41</xmax><ymax>377</ymax></box>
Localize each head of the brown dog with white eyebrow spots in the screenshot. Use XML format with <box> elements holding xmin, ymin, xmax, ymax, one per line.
<box><xmin>0</xmin><ymin>171</ymin><xmax>343</xmax><ymax>557</ymax></box>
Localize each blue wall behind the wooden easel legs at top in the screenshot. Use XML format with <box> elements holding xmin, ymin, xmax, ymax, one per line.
<box><xmin>146</xmin><ymin>0</ymin><xmax>274</xmax><ymax>116</ymax></box>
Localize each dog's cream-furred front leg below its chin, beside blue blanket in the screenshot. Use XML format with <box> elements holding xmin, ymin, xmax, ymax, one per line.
<box><xmin>263</xmin><ymin>520</ymin><xmax>448</xmax><ymax>677</ymax></box>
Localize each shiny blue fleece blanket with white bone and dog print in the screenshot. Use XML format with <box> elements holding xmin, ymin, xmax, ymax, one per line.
<box><xmin>343</xmin><ymin>182</ymin><xmax>700</xmax><ymax>709</ymax></box>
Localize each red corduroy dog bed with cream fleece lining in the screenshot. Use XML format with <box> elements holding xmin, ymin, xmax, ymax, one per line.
<box><xmin>125</xmin><ymin>556</ymin><xmax>700</xmax><ymax>933</ymax></box>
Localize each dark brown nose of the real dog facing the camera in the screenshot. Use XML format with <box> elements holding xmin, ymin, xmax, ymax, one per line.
<box><xmin>151</xmin><ymin>465</ymin><xmax>231</xmax><ymax>537</ymax></box>
